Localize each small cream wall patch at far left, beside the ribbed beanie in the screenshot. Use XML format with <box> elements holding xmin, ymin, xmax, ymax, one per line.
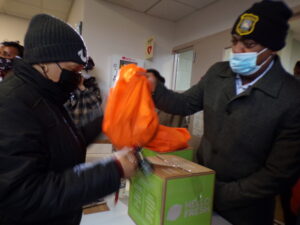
<box><xmin>0</xmin><ymin>13</ymin><xmax>29</xmax><ymax>45</ymax></box>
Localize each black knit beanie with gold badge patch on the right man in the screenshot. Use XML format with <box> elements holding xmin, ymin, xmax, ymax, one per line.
<box><xmin>231</xmin><ymin>0</ymin><xmax>293</xmax><ymax>51</ymax></box>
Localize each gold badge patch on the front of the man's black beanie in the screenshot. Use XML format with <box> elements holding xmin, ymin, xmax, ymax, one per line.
<box><xmin>235</xmin><ymin>13</ymin><xmax>259</xmax><ymax>36</ymax></box>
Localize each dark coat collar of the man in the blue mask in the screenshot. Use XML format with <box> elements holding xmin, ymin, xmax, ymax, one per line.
<box><xmin>219</xmin><ymin>56</ymin><xmax>288</xmax><ymax>99</ymax></box>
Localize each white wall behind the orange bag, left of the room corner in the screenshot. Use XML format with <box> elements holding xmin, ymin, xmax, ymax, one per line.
<box><xmin>83</xmin><ymin>0</ymin><xmax>175</xmax><ymax>103</ymax></box>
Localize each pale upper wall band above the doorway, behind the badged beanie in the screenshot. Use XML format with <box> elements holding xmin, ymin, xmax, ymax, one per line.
<box><xmin>175</xmin><ymin>0</ymin><xmax>300</xmax><ymax>46</ymax></box>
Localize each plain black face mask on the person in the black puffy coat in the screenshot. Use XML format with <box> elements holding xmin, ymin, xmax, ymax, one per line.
<box><xmin>57</xmin><ymin>64</ymin><xmax>81</xmax><ymax>94</ymax></box>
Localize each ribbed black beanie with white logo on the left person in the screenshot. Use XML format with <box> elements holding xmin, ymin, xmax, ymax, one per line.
<box><xmin>23</xmin><ymin>14</ymin><xmax>87</xmax><ymax>65</ymax></box>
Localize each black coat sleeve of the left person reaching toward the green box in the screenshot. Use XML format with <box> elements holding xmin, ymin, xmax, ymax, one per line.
<box><xmin>0</xmin><ymin>103</ymin><xmax>121</xmax><ymax>222</ymax></box>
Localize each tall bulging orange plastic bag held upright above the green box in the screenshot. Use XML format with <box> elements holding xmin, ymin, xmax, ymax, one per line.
<box><xmin>102</xmin><ymin>64</ymin><xmax>159</xmax><ymax>149</ymax></box>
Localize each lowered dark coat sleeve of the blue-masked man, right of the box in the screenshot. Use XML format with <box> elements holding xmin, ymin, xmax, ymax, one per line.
<box><xmin>215</xmin><ymin>104</ymin><xmax>300</xmax><ymax>210</ymax></box>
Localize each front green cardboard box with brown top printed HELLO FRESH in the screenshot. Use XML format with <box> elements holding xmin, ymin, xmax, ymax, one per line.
<box><xmin>128</xmin><ymin>155</ymin><xmax>215</xmax><ymax>225</ymax></box>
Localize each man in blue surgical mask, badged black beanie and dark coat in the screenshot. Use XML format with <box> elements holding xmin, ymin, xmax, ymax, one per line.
<box><xmin>149</xmin><ymin>1</ymin><xmax>300</xmax><ymax>225</ymax></box>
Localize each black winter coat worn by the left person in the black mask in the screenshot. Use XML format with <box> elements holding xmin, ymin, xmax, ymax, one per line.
<box><xmin>0</xmin><ymin>59</ymin><xmax>120</xmax><ymax>225</ymax></box>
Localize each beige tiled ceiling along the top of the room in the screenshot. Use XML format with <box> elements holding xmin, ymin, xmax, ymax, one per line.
<box><xmin>0</xmin><ymin>0</ymin><xmax>218</xmax><ymax>22</ymax></box>
